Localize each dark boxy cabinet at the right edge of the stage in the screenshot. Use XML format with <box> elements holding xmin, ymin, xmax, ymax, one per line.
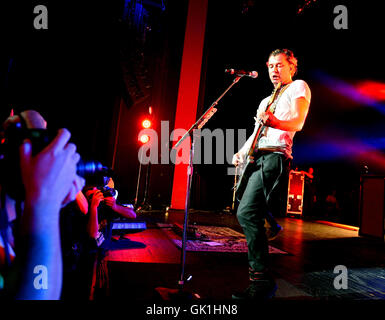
<box><xmin>359</xmin><ymin>175</ymin><xmax>385</xmax><ymax>239</ymax></box>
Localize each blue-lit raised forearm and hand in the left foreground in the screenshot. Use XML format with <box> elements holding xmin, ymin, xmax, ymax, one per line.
<box><xmin>14</xmin><ymin>129</ymin><xmax>84</xmax><ymax>300</ymax></box>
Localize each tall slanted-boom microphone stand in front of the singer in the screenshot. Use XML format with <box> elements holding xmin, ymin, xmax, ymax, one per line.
<box><xmin>156</xmin><ymin>75</ymin><xmax>244</xmax><ymax>301</ymax></box>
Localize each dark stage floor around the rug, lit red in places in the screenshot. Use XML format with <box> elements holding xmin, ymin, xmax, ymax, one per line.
<box><xmin>100</xmin><ymin>211</ymin><xmax>385</xmax><ymax>301</ymax></box>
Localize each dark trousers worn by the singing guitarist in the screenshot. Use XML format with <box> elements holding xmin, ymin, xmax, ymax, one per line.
<box><xmin>237</xmin><ymin>153</ymin><xmax>290</xmax><ymax>272</ymax></box>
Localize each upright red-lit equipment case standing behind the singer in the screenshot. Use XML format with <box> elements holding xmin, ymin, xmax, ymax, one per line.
<box><xmin>286</xmin><ymin>170</ymin><xmax>305</xmax><ymax>216</ymax></box>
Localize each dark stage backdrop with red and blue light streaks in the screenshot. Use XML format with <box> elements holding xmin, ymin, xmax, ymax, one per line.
<box><xmin>0</xmin><ymin>0</ymin><xmax>385</xmax><ymax>224</ymax></box>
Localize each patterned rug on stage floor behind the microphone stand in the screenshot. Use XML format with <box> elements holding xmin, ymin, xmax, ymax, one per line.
<box><xmin>158</xmin><ymin>225</ymin><xmax>288</xmax><ymax>254</ymax></box>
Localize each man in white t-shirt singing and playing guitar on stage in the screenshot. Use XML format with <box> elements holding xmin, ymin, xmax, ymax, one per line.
<box><xmin>233</xmin><ymin>49</ymin><xmax>311</xmax><ymax>299</ymax></box>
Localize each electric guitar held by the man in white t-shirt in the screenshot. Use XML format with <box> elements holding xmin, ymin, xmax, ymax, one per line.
<box><xmin>233</xmin><ymin>82</ymin><xmax>287</xmax><ymax>200</ymax></box>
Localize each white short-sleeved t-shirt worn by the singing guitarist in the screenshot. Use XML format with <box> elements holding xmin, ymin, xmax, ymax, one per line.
<box><xmin>239</xmin><ymin>80</ymin><xmax>311</xmax><ymax>158</ymax></box>
